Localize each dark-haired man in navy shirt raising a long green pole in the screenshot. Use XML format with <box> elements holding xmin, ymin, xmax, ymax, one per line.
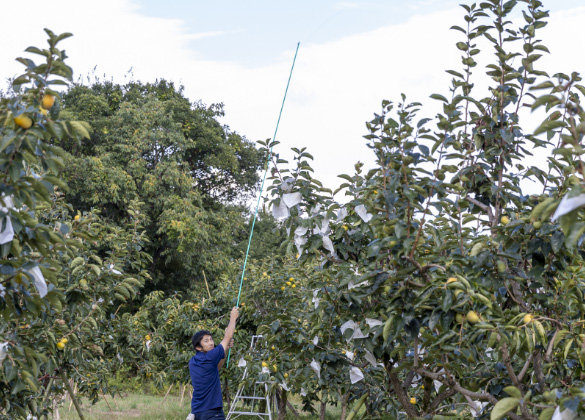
<box><xmin>187</xmin><ymin>307</ymin><xmax>240</xmax><ymax>420</ymax></box>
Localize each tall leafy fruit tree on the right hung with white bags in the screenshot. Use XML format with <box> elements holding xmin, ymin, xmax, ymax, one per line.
<box><xmin>264</xmin><ymin>0</ymin><xmax>585</xmax><ymax>420</ymax></box>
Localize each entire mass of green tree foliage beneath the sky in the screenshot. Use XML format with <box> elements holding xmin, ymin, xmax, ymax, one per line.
<box><xmin>0</xmin><ymin>0</ymin><xmax>585</xmax><ymax>420</ymax></box>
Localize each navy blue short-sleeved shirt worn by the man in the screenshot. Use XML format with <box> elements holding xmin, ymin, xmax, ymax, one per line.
<box><xmin>189</xmin><ymin>344</ymin><xmax>225</xmax><ymax>414</ymax></box>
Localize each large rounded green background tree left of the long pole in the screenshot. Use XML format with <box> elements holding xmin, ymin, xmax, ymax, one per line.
<box><xmin>59</xmin><ymin>80</ymin><xmax>282</xmax><ymax>291</ymax></box>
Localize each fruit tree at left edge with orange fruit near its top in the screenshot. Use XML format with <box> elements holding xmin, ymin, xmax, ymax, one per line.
<box><xmin>0</xmin><ymin>30</ymin><xmax>149</xmax><ymax>418</ymax></box>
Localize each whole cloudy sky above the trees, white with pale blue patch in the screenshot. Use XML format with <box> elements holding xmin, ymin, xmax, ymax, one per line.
<box><xmin>0</xmin><ymin>0</ymin><xmax>585</xmax><ymax>200</ymax></box>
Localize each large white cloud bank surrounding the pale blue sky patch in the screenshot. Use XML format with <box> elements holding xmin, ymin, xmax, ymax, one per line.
<box><xmin>0</xmin><ymin>0</ymin><xmax>585</xmax><ymax>199</ymax></box>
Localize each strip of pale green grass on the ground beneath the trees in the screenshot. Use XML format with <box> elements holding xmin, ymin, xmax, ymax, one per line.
<box><xmin>59</xmin><ymin>393</ymin><xmax>356</xmax><ymax>420</ymax></box>
